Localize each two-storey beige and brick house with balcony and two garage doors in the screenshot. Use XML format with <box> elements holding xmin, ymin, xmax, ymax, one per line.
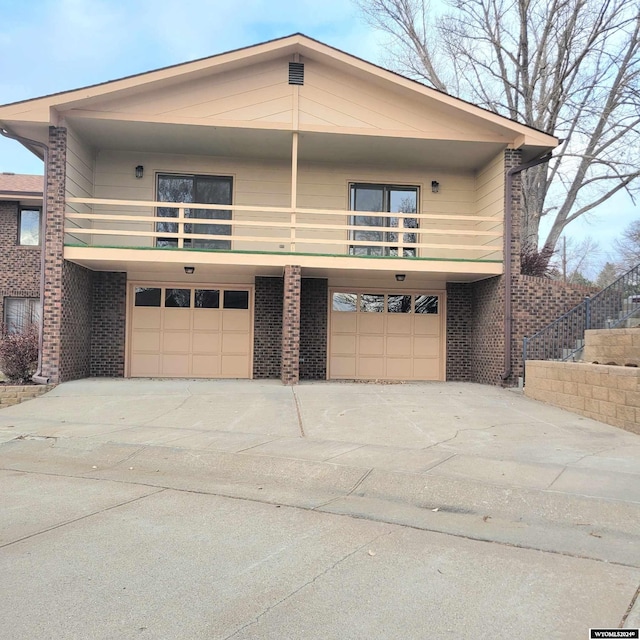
<box><xmin>0</xmin><ymin>34</ymin><xmax>582</xmax><ymax>384</ymax></box>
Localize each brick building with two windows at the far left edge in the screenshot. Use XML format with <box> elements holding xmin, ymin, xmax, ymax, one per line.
<box><xmin>0</xmin><ymin>173</ymin><xmax>44</xmax><ymax>331</ymax></box>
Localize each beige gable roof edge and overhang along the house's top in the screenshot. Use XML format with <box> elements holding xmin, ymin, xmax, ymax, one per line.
<box><xmin>0</xmin><ymin>33</ymin><xmax>557</xmax><ymax>148</ymax></box>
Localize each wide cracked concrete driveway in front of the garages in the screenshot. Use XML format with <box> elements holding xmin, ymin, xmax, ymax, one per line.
<box><xmin>0</xmin><ymin>379</ymin><xmax>640</xmax><ymax>639</ymax></box>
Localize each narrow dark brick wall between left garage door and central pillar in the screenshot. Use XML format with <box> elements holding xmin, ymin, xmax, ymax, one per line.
<box><xmin>253</xmin><ymin>276</ymin><xmax>283</xmax><ymax>378</ymax></box>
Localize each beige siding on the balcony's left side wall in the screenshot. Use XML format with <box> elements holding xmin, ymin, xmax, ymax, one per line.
<box><xmin>65</xmin><ymin>127</ymin><xmax>94</xmax><ymax>244</ymax></box>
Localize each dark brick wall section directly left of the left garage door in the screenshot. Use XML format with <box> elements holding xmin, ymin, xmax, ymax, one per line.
<box><xmin>90</xmin><ymin>271</ymin><xmax>127</xmax><ymax>378</ymax></box>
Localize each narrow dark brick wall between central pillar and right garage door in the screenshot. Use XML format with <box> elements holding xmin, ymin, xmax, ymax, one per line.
<box><xmin>300</xmin><ymin>278</ymin><xmax>329</xmax><ymax>380</ymax></box>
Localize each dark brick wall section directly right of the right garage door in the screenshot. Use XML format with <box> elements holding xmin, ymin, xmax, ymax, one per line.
<box><xmin>447</xmin><ymin>282</ymin><xmax>474</xmax><ymax>382</ymax></box>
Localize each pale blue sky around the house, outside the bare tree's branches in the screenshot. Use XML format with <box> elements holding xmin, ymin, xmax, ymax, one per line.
<box><xmin>0</xmin><ymin>0</ymin><xmax>640</xmax><ymax>259</ymax></box>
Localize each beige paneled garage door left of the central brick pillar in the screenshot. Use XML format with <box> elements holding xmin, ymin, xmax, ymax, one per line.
<box><xmin>129</xmin><ymin>286</ymin><xmax>252</xmax><ymax>378</ymax></box>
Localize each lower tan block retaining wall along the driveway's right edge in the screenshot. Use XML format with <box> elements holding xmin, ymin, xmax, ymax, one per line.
<box><xmin>524</xmin><ymin>360</ymin><xmax>640</xmax><ymax>435</ymax></box>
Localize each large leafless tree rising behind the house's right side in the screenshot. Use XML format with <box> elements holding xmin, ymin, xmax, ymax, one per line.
<box><xmin>354</xmin><ymin>0</ymin><xmax>640</xmax><ymax>264</ymax></box>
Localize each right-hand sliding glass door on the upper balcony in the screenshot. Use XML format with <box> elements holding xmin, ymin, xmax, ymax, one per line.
<box><xmin>349</xmin><ymin>183</ymin><xmax>418</xmax><ymax>257</ymax></box>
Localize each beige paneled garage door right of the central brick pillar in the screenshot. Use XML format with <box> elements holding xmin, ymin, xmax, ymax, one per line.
<box><xmin>329</xmin><ymin>291</ymin><xmax>444</xmax><ymax>380</ymax></box>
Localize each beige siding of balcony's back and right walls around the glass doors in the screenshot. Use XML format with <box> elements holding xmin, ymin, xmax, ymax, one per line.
<box><xmin>85</xmin><ymin>151</ymin><xmax>503</xmax><ymax>259</ymax></box>
